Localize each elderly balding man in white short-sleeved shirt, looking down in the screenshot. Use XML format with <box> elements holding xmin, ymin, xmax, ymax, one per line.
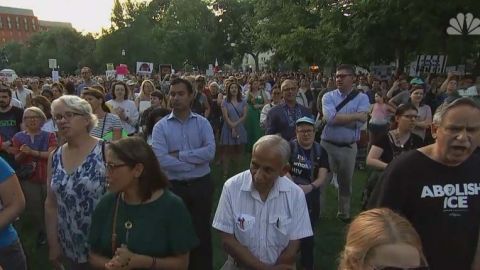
<box><xmin>213</xmin><ymin>135</ymin><xmax>313</xmax><ymax>270</ymax></box>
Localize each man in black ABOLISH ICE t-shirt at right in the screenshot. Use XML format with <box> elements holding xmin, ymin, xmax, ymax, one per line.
<box><xmin>369</xmin><ymin>98</ymin><xmax>480</xmax><ymax>270</ymax></box>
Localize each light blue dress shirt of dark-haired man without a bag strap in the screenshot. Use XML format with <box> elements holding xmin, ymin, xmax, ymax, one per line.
<box><xmin>152</xmin><ymin>112</ymin><xmax>215</xmax><ymax>180</ymax></box>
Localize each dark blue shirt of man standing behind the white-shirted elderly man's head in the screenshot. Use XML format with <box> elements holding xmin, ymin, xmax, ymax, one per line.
<box><xmin>266</xmin><ymin>103</ymin><xmax>313</xmax><ymax>141</ymax></box>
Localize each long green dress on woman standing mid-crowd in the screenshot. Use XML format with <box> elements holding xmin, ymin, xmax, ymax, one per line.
<box><xmin>245</xmin><ymin>91</ymin><xmax>265</xmax><ymax>152</ymax></box>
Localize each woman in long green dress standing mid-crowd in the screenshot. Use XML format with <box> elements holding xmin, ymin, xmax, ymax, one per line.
<box><xmin>245</xmin><ymin>77</ymin><xmax>270</xmax><ymax>152</ymax></box>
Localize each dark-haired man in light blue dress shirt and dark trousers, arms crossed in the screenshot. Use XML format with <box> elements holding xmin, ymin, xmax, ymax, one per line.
<box><xmin>152</xmin><ymin>78</ymin><xmax>215</xmax><ymax>270</ymax></box>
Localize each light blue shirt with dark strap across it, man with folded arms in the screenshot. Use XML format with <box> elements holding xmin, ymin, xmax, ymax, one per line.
<box><xmin>322</xmin><ymin>89</ymin><xmax>370</xmax><ymax>143</ymax></box>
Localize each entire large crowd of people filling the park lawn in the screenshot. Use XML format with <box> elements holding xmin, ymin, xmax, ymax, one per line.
<box><xmin>0</xmin><ymin>64</ymin><xmax>480</xmax><ymax>270</ymax></box>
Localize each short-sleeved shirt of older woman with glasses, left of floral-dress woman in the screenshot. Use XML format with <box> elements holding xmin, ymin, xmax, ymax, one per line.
<box><xmin>12</xmin><ymin>131</ymin><xmax>57</xmax><ymax>184</ymax></box>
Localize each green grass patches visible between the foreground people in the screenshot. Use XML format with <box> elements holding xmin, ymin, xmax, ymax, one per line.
<box><xmin>15</xmin><ymin>156</ymin><xmax>367</xmax><ymax>270</ymax></box>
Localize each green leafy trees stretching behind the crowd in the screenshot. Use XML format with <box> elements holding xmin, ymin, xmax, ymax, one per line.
<box><xmin>3</xmin><ymin>0</ymin><xmax>480</xmax><ymax>75</ymax></box>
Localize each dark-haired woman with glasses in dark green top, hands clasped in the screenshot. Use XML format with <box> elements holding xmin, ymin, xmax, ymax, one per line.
<box><xmin>89</xmin><ymin>137</ymin><xmax>198</xmax><ymax>269</ymax></box>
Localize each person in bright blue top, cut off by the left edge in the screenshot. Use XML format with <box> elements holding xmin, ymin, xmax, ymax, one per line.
<box><xmin>0</xmin><ymin>156</ymin><xmax>27</xmax><ymax>270</ymax></box>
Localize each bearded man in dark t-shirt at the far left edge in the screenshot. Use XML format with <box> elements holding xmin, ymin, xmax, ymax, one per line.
<box><xmin>0</xmin><ymin>85</ymin><xmax>23</xmax><ymax>167</ymax></box>
